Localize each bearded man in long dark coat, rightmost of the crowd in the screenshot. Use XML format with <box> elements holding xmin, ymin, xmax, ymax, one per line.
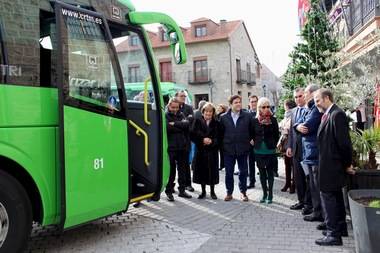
<box><xmin>314</xmin><ymin>89</ymin><xmax>352</xmax><ymax>246</ymax></box>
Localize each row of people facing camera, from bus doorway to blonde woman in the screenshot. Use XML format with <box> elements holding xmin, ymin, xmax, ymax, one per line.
<box><xmin>165</xmin><ymin>91</ymin><xmax>279</xmax><ymax>204</ymax></box>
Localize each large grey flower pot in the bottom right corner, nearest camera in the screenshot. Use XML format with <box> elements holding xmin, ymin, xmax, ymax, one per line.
<box><xmin>348</xmin><ymin>189</ymin><xmax>380</xmax><ymax>253</ymax></box>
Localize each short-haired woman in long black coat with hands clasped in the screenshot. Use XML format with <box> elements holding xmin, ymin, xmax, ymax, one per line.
<box><xmin>190</xmin><ymin>103</ymin><xmax>219</xmax><ymax>199</ymax></box>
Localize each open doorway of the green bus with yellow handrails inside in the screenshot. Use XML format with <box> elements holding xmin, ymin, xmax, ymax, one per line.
<box><xmin>110</xmin><ymin>24</ymin><xmax>163</xmax><ymax>202</ymax></box>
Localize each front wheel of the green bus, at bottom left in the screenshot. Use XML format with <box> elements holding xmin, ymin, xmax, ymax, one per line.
<box><xmin>0</xmin><ymin>170</ymin><xmax>32</xmax><ymax>253</ymax></box>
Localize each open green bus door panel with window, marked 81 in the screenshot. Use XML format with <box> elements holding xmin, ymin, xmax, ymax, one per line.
<box><xmin>55</xmin><ymin>2</ymin><xmax>130</xmax><ymax>228</ymax></box>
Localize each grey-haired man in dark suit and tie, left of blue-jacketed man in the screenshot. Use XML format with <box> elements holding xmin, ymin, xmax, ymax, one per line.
<box><xmin>286</xmin><ymin>88</ymin><xmax>312</xmax><ymax>215</ymax></box>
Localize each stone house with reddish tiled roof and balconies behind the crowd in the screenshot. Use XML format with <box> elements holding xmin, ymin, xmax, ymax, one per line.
<box><xmin>145</xmin><ymin>18</ymin><xmax>262</xmax><ymax>107</ymax></box>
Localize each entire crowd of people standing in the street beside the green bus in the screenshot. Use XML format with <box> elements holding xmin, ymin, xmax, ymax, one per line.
<box><xmin>165</xmin><ymin>84</ymin><xmax>352</xmax><ymax>245</ymax></box>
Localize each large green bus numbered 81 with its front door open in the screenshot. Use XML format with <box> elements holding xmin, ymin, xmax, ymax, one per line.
<box><xmin>0</xmin><ymin>0</ymin><xmax>187</xmax><ymax>253</ymax></box>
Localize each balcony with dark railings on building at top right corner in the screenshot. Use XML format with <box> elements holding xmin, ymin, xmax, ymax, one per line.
<box><xmin>345</xmin><ymin>0</ymin><xmax>380</xmax><ymax>35</ymax></box>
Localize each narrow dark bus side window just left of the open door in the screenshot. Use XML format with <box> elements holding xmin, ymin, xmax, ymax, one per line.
<box><xmin>39</xmin><ymin>11</ymin><xmax>57</xmax><ymax>87</ymax></box>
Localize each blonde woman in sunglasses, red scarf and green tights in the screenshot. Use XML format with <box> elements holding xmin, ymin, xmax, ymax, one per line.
<box><xmin>253</xmin><ymin>97</ymin><xmax>279</xmax><ymax>204</ymax></box>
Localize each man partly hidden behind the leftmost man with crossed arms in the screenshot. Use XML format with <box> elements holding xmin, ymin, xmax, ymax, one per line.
<box><xmin>175</xmin><ymin>90</ymin><xmax>194</xmax><ymax>192</ymax></box>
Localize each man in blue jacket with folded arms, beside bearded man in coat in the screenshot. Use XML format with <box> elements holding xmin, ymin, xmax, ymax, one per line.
<box><xmin>294</xmin><ymin>84</ymin><xmax>323</xmax><ymax>222</ymax></box>
